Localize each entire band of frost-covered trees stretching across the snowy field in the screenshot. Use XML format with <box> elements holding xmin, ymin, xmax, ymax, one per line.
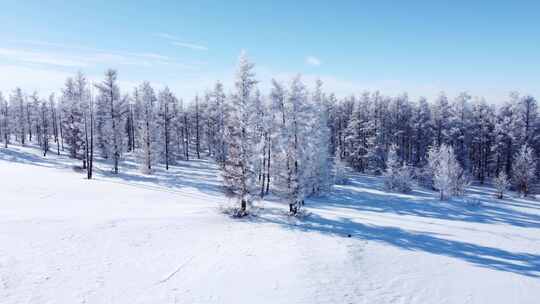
<box><xmin>0</xmin><ymin>54</ymin><xmax>540</xmax><ymax>211</ymax></box>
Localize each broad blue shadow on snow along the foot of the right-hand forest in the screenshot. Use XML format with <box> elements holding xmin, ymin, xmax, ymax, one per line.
<box><xmin>310</xmin><ymin>175</ymin><xmax>540</xmax><ymax>228</ymax></box>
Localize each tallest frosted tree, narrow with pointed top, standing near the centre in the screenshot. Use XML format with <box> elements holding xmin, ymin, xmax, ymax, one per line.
<box><xmin>223</xmin><ymin>52</ymin><xmax>258</xmax><ymax>216</ymax></box>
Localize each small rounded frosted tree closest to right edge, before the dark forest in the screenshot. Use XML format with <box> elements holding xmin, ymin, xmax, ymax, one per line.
<box><xmin>512</xmin><ymin>144</ymin><xmax>536</xmax><ymax>196</ymax></box>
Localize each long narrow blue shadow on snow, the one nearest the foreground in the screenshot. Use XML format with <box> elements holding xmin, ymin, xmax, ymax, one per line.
<box><xmin>253</xmin><ymin>214</ymin><xmax>540</xmax><ymax>277</ymax></box>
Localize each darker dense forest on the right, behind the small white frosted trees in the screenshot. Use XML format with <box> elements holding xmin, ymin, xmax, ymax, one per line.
<box><xmin>336</xmin><ymin>92</ymin><xmax>540</xmax><ymax>194</ymax></box>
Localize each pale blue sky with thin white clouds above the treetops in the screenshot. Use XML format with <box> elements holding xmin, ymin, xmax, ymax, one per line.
<box><xmin>0</xmin><ymin>0</ymin><xmax>540</xmax><ymax>102</ymax></box>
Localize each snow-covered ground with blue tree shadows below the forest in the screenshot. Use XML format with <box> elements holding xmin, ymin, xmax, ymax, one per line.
<box><xmin>0</xmin><ymin>147</ymin><xmax>540</xmax><ymax>304</ymax></box>
